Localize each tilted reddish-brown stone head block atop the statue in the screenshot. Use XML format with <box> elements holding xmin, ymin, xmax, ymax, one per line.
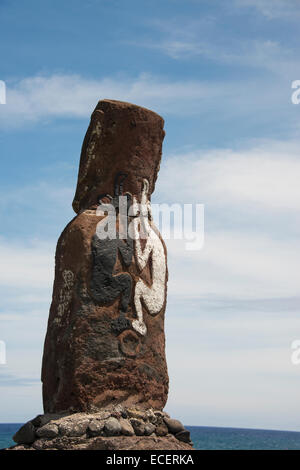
<box><xmin>73</xmin><ymin>100</ymin><xmax>165</xmax><ymax>214</ymax></box>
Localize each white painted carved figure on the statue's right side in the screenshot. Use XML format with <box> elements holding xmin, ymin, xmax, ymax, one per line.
<box><xmin>132</xmin><ymin>179</ymin><xmax>167</xmax><ymax>335</ymax></box>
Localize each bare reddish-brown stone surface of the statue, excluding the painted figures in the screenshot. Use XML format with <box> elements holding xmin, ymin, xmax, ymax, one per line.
<box><xmin>42</xmin><ymin>100</ymin><xmax>168</xmax><ymax>413</ymax></box>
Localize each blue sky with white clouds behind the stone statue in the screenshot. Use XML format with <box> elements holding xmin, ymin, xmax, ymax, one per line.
<box><xmin>0</xmin><ymin>0</ymin><xmax>300</xmax><ymax>431</ymax></box>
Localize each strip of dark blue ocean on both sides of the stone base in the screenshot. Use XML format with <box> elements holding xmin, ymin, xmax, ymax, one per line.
<box><xmin>0</xmin><ymin>423</ymin><xmax>300</xmax><ymax>450</ymax></box>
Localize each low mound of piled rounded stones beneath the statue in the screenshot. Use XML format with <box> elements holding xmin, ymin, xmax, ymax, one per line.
<box><xmin>8</xmin><ymin>405</ymin><xmax>193</xmax><ymax>451</ymax></box>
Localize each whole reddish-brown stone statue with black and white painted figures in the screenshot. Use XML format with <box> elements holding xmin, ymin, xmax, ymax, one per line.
<box><xmin>42</xmin><ymin>100</ymin><xmax>168</xmax><ymax>413</ymax></box>
